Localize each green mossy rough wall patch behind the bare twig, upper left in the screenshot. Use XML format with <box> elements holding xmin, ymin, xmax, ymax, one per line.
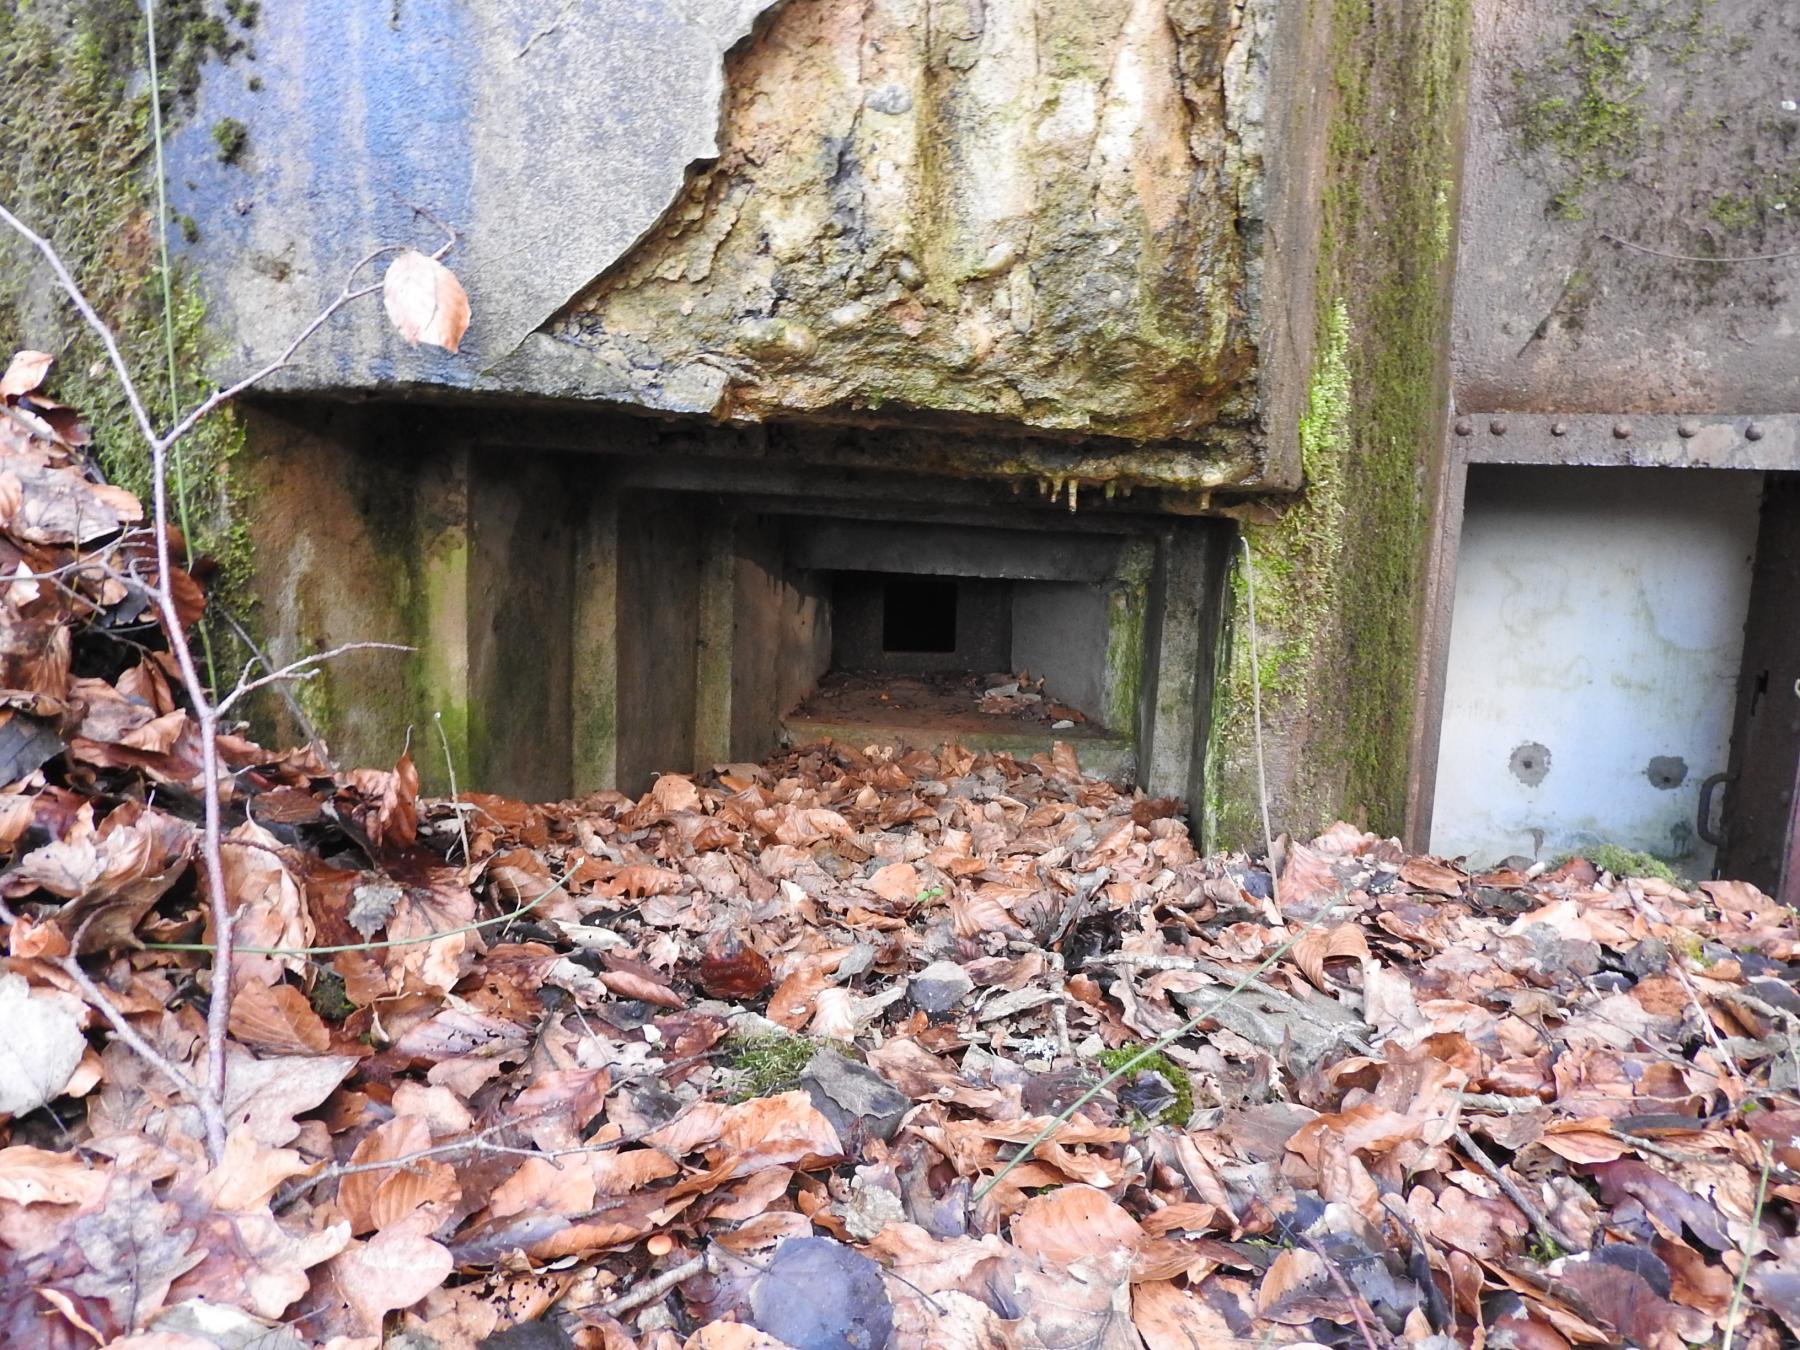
<box><xmin>0</xmin><ymin>0</ymin><xmax>261</xmax><ymax>687</ymax></box>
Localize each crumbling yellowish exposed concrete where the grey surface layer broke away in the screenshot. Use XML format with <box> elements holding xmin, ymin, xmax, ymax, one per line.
<box><xmin>549</xmin><ymin>0</ymin><xmax>1256</xmax><ymax>488</ymax></box>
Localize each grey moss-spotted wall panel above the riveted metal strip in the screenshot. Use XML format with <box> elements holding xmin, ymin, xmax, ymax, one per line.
<box><xmin>1454</xmin><ymin>0</ymin><xmax>1800</xmax><ymax>414</ymax></box>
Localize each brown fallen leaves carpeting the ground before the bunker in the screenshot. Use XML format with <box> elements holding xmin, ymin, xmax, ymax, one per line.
<box><xmin>0</xmin><ymin>373</ymin><xmax>1800</xmax><ymax>1350</ymax></box>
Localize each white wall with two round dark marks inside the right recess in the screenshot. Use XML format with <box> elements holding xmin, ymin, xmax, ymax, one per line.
<box><xmin>1431</xmin><ymin>468</ymin><xmax>1762</xmax><ymax>877</ymax></box>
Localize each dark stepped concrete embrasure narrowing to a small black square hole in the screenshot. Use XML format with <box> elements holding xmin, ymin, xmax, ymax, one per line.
<box><xmin>243</xmin><ymin>400</ymin><xmax>1233</xmax><ymax>813</ymax></box>
